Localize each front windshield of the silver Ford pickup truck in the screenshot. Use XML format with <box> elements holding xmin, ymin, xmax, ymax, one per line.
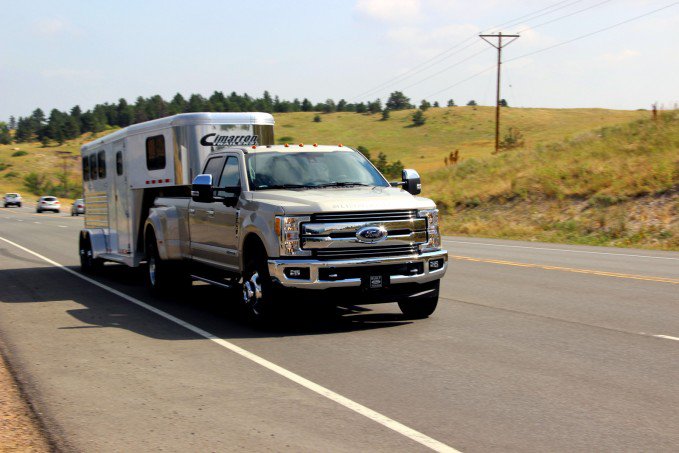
<box><xmin>247</xmin><ymin>151</ymin><xmax>389</xmax><ymax>190</ymax></box>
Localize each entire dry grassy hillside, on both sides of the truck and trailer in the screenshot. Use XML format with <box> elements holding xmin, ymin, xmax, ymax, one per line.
<box><xmin>0</xmin><ymin>107</ymin><xmax>679</xmax><ymax>249</ymax></box>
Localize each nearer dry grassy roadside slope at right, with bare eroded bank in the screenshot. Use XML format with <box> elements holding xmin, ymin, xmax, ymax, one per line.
<box><xmin>432</xmin><ymin>112</ymin><xmax>679</xmax><ymax>250</ymax></box>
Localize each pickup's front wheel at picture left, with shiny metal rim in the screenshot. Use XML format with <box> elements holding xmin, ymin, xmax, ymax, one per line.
<box><xmin>241</xmin><ymin>245</ymin><xmax>277</xmax><ymax>324</ymax></box>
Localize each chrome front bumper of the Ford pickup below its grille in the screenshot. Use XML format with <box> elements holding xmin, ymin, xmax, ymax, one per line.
<box><xmin>268</xmin><ymin>250</ymin><xmax>448</xmax><ymax>289</ymax></box>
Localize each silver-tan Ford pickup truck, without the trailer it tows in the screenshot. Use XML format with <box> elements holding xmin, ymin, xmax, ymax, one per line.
<box><xmin>143</xmin><ymin>145</ymin><xmax>448</xmax><ymax>319</ymax></box>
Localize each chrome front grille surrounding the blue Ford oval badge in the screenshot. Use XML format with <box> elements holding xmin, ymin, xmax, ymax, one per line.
<box><xmin>300</xmin><ymin>210</ymin><xmax>427</xmax><ymax>260</ymax></box>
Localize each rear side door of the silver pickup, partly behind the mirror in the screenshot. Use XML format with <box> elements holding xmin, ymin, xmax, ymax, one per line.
<box><xmin>189</xmin><ymin>155</ymin><xmax>226</xmax><ymax>265</ymax></box>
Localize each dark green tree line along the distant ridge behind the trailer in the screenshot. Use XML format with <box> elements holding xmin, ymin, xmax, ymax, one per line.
<box><xmin>6</xmin><ymin>91</ymin><xmax>504</xmax><ymax>145</ymax></box>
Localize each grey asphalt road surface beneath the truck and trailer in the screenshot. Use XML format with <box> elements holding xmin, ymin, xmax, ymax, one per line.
<box><xmin>0</xmin><ymin>208</ymin><xmax>679</xmax><ymax>452</ymax></box>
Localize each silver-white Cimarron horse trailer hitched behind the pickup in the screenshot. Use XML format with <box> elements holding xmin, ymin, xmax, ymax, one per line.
<box><xmin>79</xmin><ymin>113</ymin><xmax>274</xmax><ymax>266</ymax></box>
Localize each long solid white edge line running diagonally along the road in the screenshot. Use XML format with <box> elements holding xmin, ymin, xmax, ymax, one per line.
<box><xmin>0</xmin><ymin>237</ymin><xmax>459</xmax><ymax>453</ymax></box>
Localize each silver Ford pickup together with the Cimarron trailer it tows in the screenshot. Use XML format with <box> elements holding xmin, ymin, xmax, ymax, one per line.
<box><xmin>79</xmin><ymin>113</ymin><xmax>448</xmax><ymax>320</ymax></box>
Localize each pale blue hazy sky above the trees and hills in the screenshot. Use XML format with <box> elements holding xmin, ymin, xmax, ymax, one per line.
<box><xmin>0</xmin><ymin>0</ymin><xmax>679</xmax><ymax>120</ymax></box>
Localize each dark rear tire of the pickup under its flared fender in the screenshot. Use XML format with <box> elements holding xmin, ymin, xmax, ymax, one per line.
<box><xmin>146</xmin><ymin>232</ymin><xmax>191</xmax><ymax>295</ymax></box>
